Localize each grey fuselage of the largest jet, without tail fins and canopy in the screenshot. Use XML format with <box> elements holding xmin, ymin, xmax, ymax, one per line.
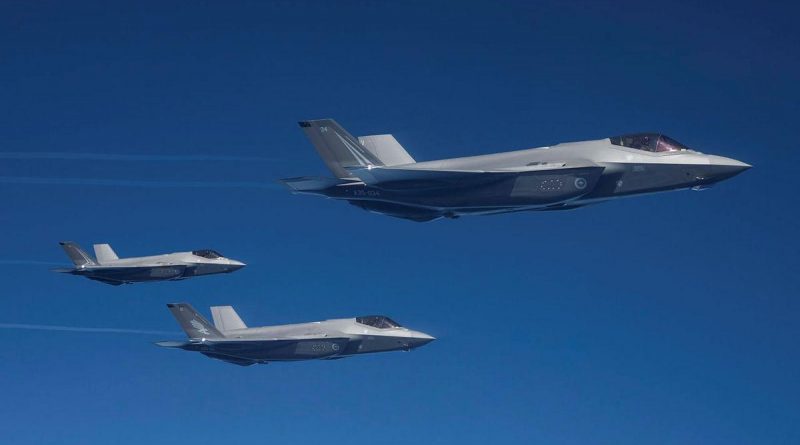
<box><xmin>287</xmin><ymin>134</ymin><xmax>749</xmax><ymax>221</ymax></box>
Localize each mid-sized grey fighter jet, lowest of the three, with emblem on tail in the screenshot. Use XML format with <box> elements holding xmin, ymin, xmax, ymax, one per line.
<box><xmin>156</xmin><ymin>303</ymin><xmax>434</xmax><ymax>366</ymax></box>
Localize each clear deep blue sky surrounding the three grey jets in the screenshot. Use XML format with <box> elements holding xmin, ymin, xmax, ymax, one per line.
<box><xmin>0</xmin><ymin>1</ymin><xmax>800</xmax><ymax>445</ymax></box>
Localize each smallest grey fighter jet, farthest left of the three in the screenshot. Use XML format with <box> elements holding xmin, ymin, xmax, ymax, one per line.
<box><xmin>55</xmin><ymin>241</ymin><xmax>245</xmax><ymax>286</ymax></box>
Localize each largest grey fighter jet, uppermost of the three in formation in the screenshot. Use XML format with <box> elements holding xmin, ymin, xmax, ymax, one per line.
<box><xmin>281</xmin><ymin>119</ymin><xmax>750</xmax><ymax>221</ymax></box>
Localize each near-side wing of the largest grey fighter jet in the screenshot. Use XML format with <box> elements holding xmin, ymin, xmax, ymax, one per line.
<box><xmin>349</xmin><ymin>162</ymin><xmax>604</xmax><ymax>189</ymax></box>
